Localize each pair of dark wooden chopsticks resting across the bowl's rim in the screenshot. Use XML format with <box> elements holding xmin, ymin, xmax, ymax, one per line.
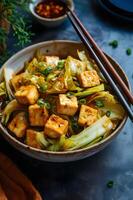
<box><xmin>62</xmin><ymin>1</ymin><xmax>133</xmax><ymax>121</ymax></box>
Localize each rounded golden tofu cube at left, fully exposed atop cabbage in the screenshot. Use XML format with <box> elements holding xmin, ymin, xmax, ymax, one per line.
<box><xmin>15</xmin><ymin>85</ymin><xmax>39</xmax><ymax>105</ymax></box>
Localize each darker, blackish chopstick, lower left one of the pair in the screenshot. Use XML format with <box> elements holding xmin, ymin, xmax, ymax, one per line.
<box><xmin>66</xmin><ymin>8</ymin><xmax>133</xmax><ymax>121</ymax></box>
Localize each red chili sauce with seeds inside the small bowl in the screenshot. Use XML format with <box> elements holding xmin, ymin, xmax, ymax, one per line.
<box><xmin>35</xmin><ymin>0</ymin><xmax>66</xmax><ymax>18</ymax></box>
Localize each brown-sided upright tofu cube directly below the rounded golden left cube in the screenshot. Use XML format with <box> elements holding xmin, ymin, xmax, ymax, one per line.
<box><xmin>29</xmin><ymin>104</ymin><xmax>48</xmax><ymax>126</ymax></box>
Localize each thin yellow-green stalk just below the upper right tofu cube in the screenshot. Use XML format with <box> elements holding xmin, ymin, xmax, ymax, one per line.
<box><xmin>74</xmin><ymin>83</ymin><xmax>104</xmax><ymax>97</ymax></box>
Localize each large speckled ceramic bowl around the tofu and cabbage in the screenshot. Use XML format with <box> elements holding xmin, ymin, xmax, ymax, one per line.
<box><xmin>0</xmin><ymin>40</ymin><xmax>130</xmax><ymax>162</ymax></box>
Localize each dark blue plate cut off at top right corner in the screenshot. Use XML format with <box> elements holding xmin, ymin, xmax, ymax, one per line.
<box><xmin>98</xmin><ymin>0</ymin><xmax>133</xmax><ymax>21</ymax></box>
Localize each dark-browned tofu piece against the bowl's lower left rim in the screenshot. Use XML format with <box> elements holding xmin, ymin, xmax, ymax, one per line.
<box><xmin>8</xmin><ymin>112</ymin><xmax>28</xmax><ymax>138</ymax></box>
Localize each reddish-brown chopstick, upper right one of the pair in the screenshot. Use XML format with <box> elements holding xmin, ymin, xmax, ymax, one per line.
<box><xmin>68</xmin><ymin>8</ymin><xmax>133</xmax><ymax>104</ymax></box>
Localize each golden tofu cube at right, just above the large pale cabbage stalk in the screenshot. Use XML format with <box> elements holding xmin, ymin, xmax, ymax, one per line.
<box><xmin>78</xmin><ymin>105</ymin><xmax>98</xmax><ymax>126</ymax></box>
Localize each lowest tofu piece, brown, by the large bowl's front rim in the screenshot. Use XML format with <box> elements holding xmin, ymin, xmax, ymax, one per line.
<box><xmin>26</xmin><ymin>129</ymin><xmax>41</xmax><ymax>149</ymax></box>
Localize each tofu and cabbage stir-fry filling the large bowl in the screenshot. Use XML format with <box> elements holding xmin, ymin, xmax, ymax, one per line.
<box><xmin>0</xmin><ymin>51</ymin><xmax>125</xmax><ymax>151</ymax></box>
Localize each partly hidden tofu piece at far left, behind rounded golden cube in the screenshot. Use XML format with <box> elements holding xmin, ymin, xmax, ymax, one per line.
<box><xmin>11</xmin><ymin>73</ymin><xmax>25</xmax><ymax>91</ymax></box>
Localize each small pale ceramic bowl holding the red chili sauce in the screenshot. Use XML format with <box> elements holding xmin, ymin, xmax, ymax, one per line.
<box><xmin>29</xmin><ymin>0</ymin><xmax>74</xmax><ymax>28</ymax></box>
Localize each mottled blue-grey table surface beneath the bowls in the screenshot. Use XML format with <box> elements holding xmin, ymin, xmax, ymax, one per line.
<box><xmin>0</xmin><ymin>0</ymin><xmax>133</xmax><ymax>200</ymax></box>
